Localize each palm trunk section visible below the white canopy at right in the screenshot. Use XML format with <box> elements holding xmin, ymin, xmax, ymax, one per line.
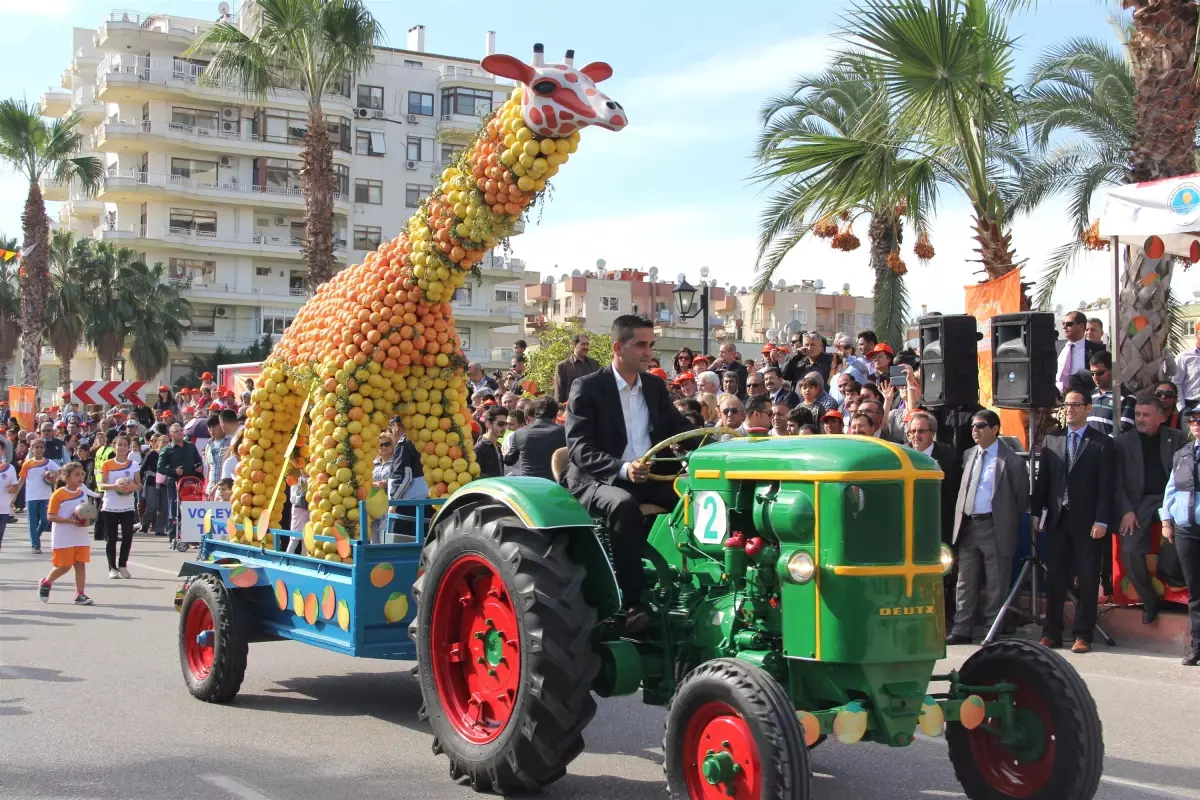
<box><xmin>1112</xmin><ymin>247</ymin><xmax>1175</xmax><ymax>391</ymax></box>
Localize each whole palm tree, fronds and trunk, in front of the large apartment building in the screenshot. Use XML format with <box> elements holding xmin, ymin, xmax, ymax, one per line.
<box><xmin>186</xmin><ymin>0</ymin><xmax>384</xmax><ymax>291</ymax></box>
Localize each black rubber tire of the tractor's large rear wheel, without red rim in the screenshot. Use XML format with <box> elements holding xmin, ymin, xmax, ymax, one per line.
<box><xmin>409</xmin><ymin>504</ymin><xmax>600</xmax><ymax>794</ymax></box>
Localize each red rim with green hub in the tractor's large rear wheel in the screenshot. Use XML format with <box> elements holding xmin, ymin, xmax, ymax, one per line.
<box><xmin>430</xmin><ymin>554</ymin><xmax>521</xmax><ymax>745</ymax></box>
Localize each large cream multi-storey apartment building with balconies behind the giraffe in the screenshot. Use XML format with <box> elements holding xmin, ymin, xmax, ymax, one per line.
<box><xmin>42</xmin><ymin>8</ymin><xmax>524</xmax><ymax>386</ymax></box>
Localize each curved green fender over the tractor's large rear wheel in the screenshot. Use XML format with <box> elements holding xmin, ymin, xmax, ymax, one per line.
<box><xmin>428</xmin><ymin>476</ymin><xmax>622</xmax><ymax>619</ymax></box>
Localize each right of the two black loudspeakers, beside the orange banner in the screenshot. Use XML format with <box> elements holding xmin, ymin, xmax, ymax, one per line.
<box><xmin>991</xmin><ymin>311</ymin><xmax>1058</xmax><ymax>408</ymax></box>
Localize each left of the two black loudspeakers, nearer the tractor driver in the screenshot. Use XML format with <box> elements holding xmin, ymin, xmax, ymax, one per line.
<box><xmin>918</xmin><ymin>314</ymin><xmax>983</xmax><ymax>408</ymax></box>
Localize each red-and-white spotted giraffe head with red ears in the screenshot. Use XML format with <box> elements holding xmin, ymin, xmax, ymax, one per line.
<box><xmin>482</xmin><ymin>44</ymin><xmax>628</xmax><ymax>137</ymax></box>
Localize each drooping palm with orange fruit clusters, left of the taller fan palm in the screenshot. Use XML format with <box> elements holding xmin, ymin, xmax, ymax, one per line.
<box><xmin>755</xmin><ymin>56</ymin><xmax>937</xmax><ymax>347</ymax></box>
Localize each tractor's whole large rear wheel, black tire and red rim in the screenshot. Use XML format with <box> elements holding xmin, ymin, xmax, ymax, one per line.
<box><xmin>410</xmin><ymin>504</ymin><xmax>600</xmax><ymax>793</ymax></box>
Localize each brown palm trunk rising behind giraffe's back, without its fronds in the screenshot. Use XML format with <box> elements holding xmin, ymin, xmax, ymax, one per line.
<box><xmin>300</xmin><ymin>108</ymin><xmax>338</xmax><ymax>291</ymax></box>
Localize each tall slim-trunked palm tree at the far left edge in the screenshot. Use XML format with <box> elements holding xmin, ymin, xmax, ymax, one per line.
<box><xmin>0</xmin><ymin>100</ymin><xmax>103</xmax><ymax>386</ymax></box>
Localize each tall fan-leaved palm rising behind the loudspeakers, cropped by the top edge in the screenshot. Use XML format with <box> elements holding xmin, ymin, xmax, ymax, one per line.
<box><xmin>844</xmin><ymin>0</ymin><xmax>1024</xmax><ymax>278</ymax></box>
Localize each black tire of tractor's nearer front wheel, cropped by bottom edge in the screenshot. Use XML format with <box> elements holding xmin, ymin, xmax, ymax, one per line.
<box><xmin>662</xmin><ymin>658</ymin><xmax>811</xmax><ymax>800</ymax></box>
